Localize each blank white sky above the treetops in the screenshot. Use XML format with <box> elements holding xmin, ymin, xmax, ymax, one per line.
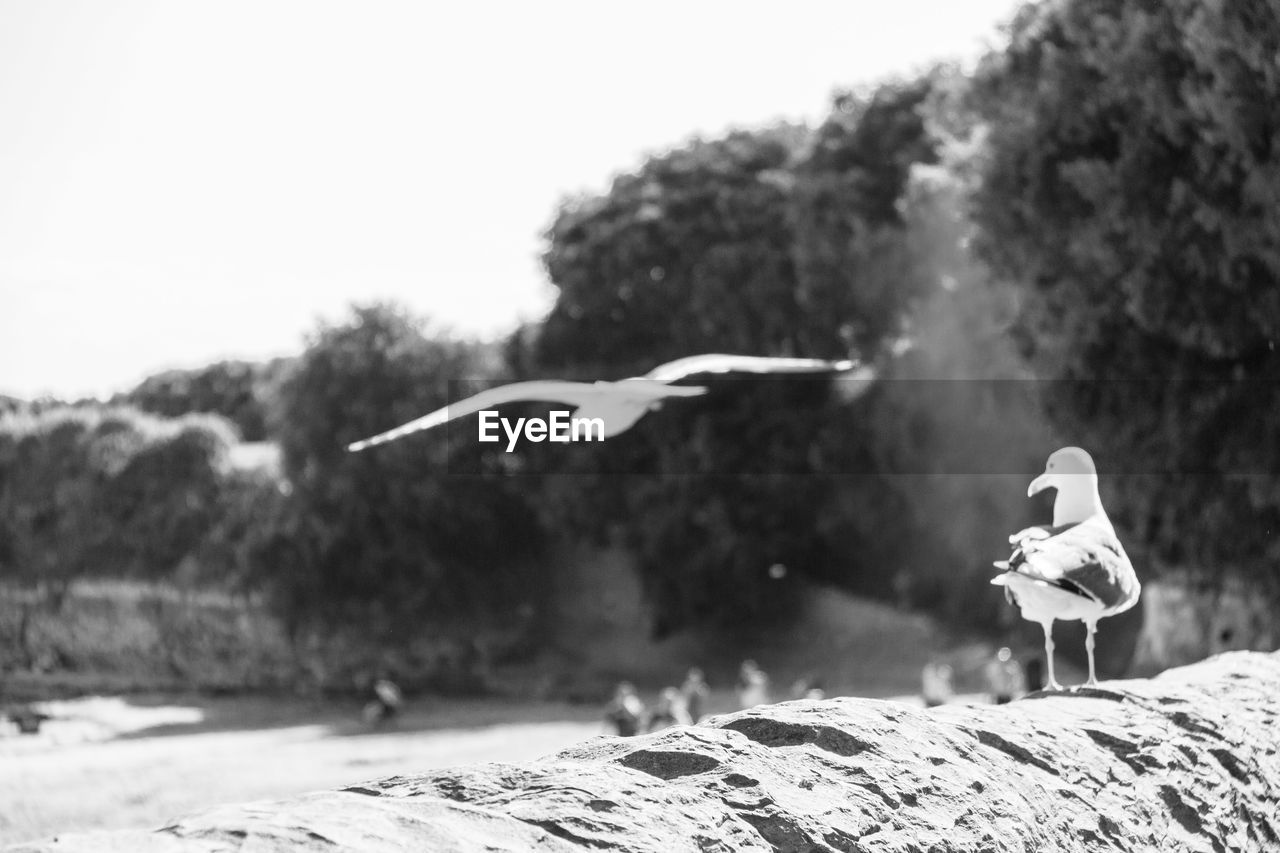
<box><xmin>0</xmin><ymin>0</ymin><xmax>1014</xmax><ymax>398</ymax></box>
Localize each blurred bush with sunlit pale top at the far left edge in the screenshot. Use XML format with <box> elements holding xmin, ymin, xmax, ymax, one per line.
<box><xmin>0</xmin><ymin>406</ymin><xmax>233</xmax><ymax>662</ymax></box>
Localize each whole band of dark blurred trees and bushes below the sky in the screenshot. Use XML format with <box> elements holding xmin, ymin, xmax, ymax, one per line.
<box><xmin>12</xmin><ymin>0</ymin><xmax>1280</xmax><ymax>665</ymax></box>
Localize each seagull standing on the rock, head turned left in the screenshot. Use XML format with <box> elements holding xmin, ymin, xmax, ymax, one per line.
<box><xmin>991</xmin><ymin>447</ymin><xmax>1140</xmax><ymax>690</ymax></box>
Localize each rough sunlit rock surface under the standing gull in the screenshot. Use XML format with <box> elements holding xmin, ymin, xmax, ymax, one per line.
<box><xmin>15</xmin><ymin>652</ymin><xmax>1280</xmax><ymax>853</ymax></box>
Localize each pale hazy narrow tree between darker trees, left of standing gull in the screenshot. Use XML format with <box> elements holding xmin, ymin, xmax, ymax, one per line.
<box><xmin>824</xmin><ymin>140</ymin><xmax>1056</xmax><ymax>628</ymax></box>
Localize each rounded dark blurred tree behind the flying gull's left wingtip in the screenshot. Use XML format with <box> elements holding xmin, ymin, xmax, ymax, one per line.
<box><xmin>267</xmin><ymin>305</ymin><xmax>541</xmax><ymax>640</ymax></box>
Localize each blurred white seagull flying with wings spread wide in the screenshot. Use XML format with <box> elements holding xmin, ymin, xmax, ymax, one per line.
<box><xmin>347</xmin><ymin>355</ymin><xmax>865</xmax><ymax>452</ymax></box>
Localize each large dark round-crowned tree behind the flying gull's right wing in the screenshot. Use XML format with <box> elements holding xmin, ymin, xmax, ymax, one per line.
<box><xmin>524</xmin><ymin>81</ymin><xmax>936</xmax><ymax>634</ymax></box>
